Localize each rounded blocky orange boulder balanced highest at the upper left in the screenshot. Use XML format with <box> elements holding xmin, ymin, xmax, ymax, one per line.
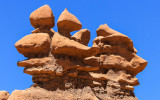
<box><xmin>30</xmin><ymin>5</ymin><xmax>55</xmax><ymax>28</ymax></box>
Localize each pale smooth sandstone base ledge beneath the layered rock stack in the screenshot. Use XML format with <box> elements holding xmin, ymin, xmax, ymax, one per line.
<box><xmin>8</xmin><ymin>87</ymin><xmax>99</xmax><ymax>100</ymax></box>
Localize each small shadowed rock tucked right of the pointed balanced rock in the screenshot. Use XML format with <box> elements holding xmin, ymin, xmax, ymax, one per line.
<box><xmin>71</xmin><ymin>29</ymin><xmax>90</xmax><ymax>45</ymax></box>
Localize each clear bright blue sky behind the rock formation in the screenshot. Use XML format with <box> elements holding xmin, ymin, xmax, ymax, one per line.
<box><xmin>0</xmin><ymin>0</ymin><xmax>160</xmax><ymax>100</ymax></box>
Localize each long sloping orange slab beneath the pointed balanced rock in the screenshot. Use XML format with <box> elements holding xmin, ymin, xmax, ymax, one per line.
<box><xmin>52</xmin><ymin>33</ymin><xmax>99</xmax><ymax>58</ymax></box>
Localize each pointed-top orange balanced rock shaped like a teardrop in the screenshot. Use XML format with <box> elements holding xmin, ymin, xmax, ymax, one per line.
<box><xmin>57</xmin><ymin>9</ymin><xmax>82</xmax><ymax>37</ymax></box>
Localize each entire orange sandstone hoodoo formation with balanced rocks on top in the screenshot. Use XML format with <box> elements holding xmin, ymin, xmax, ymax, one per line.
<box><xmin>2</xmin><ymin>5</ymin><xmax>147</xmax><ymax>100</ymax></box>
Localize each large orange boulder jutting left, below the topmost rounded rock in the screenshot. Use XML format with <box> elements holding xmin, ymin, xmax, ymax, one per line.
<box><xmin>15</xmin><ymin>33</ymin><xmax>50</xmax><ymax>57</ymax></box>
